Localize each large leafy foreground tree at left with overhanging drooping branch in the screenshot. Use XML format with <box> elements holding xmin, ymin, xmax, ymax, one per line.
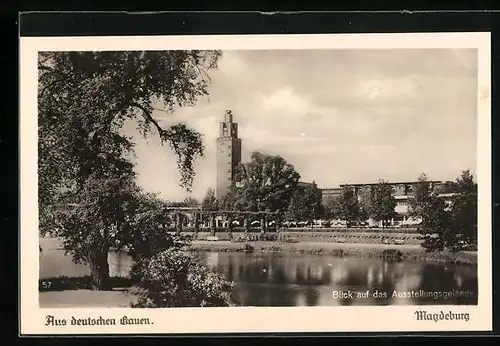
<box><xmin>38</xmin><ymin>51</ymin><xmax>220</xmax><ymax>289</ymax></box>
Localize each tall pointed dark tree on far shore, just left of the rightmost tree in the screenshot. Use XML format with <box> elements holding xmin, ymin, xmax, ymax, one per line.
<box><xmin>408</xmin><ymin>173</ymin><xmax>452</xmax><ymax>251</ymax></box>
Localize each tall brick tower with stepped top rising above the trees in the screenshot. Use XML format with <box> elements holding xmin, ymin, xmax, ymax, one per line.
<box><xmin>215</xmin><ymin>110</ymin><xmax>241</xmax><ymax>198</ymax></box>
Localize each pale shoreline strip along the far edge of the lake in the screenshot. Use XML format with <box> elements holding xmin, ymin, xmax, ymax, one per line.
<box><xmin>188</xmin><ymin>240</ymin><xmax>477</xmax><ymax>265</ymax></box>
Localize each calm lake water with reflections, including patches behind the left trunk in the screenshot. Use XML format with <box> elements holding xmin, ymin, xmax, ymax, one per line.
<box><xmin>40</xmin><ymin>238</ymin><xmax>477</xmax><ymax>306</ymax></box>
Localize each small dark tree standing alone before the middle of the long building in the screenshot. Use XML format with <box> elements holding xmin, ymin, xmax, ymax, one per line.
<box><xmin>370</xmin><ymin>179</ymin><xmax>396</xmax><ymax>228</ymax></box>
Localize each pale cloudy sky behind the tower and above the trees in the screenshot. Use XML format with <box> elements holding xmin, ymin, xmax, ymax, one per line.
<box><xmin>125</xmin><ymin>49</ymin><xmax>477</xmax><ymax>201</ymax></box>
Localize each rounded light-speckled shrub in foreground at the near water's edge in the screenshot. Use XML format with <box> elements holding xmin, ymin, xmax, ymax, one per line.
<box><xmin>132</xmin><ymin>249</ymin><xmax>235</xmax><ymax>308</ymax></box>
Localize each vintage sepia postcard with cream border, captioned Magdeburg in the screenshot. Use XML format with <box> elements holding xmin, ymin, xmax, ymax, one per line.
<box><xmin>20</xmin><ymin>33</ymin><xmax>492</xmax><ymax>334</ymax></box>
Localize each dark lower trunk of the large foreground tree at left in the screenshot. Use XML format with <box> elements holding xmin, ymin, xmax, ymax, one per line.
<box><xmin>88</xmin><ymin>242</ymin><xmax>111</xmax><ymax>291</ymax></box>
